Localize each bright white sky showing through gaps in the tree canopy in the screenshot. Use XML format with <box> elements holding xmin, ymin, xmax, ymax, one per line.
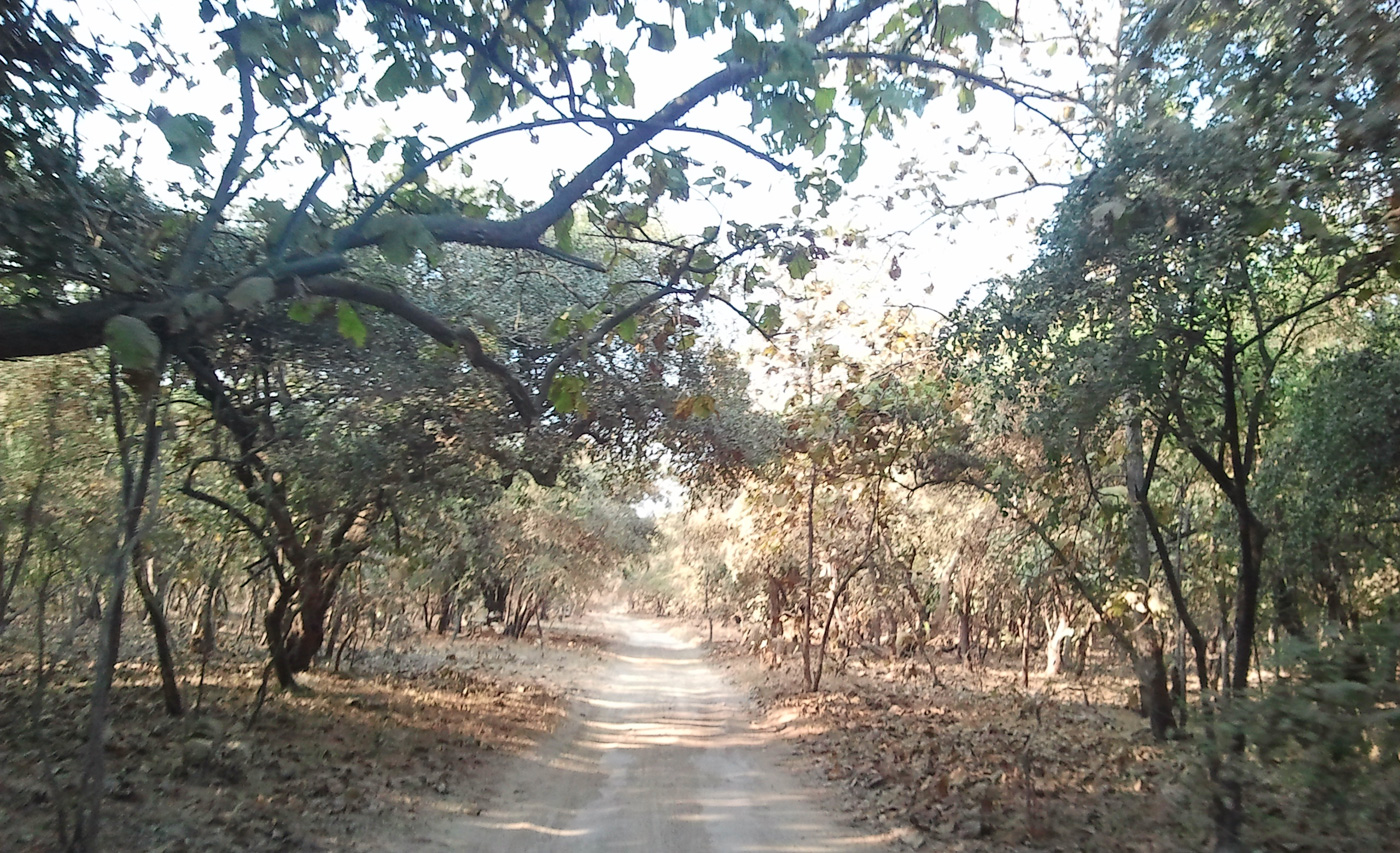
<box><xmin>77</xmin><ymin>0</ymin><xmax>1117</xmax><ymax>392</ymax></box>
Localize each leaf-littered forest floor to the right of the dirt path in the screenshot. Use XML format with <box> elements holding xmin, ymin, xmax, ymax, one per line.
<box><xmin>711</xmin><ymin>627</ymin><xmax>1211</xmax><ymax>853</ymax></box>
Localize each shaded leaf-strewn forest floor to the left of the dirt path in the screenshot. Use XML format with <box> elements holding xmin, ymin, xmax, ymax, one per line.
<box><xmin>0</xmin><ymin>620</ymin><xmax>603</xmax><ymax>853</ymax></box>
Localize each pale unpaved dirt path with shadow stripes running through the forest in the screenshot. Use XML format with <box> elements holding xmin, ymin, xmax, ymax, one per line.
<box><xmin>378</xmin><ymin>613</ymin><xmax>886</xmax><ymax>853</ymax></box>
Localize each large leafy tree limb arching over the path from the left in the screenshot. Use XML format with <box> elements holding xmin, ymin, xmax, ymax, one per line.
<box><xmin>0</xmin><ymin>0</ymin><xmax>1080</xmax><ymax>392</ymax></box>
